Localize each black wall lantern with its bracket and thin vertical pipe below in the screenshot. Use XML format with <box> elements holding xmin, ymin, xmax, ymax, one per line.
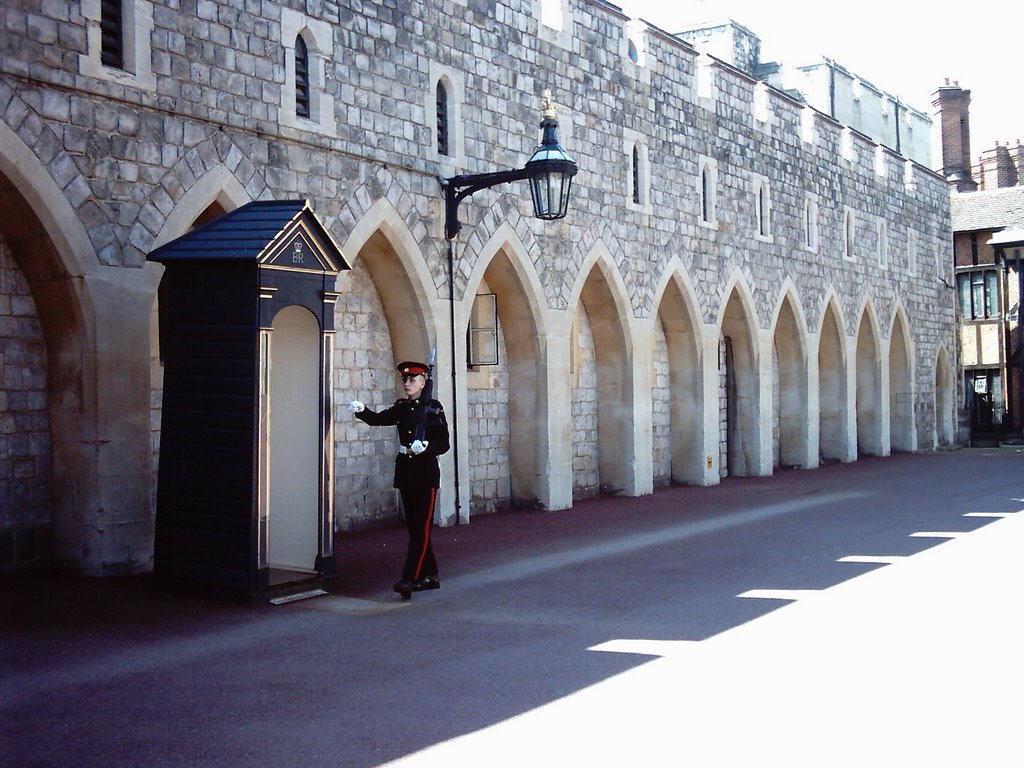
<box><xmin>441</xmin><ymin>90</ymin><xmax>579</xmax><ymax>525</ymax></box>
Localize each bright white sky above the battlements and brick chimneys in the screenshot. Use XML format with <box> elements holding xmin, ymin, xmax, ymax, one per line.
<box><xmin>610</xmin><ymin>0</ymin><xmax>1024</xmax><ymax>163</ymax></box>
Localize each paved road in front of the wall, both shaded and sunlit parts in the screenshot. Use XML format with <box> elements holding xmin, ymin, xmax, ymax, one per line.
<box><xmin>0</xmin><ymin>449</ymin><xmax>1024</xmax><ymax>768</ymax></box>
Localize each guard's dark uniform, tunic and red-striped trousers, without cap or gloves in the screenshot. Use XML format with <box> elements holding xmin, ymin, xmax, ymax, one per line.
<box><xmin>355</xmin><ymin>398</ymin><xmax>450</xmax><ymax>582</ymax></box>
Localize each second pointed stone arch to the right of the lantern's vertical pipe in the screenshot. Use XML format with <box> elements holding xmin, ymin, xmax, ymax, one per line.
<box><xmin>569</xmin><ymin>242</ymin><xmax>635</xmax><ymax>498</ymax></box>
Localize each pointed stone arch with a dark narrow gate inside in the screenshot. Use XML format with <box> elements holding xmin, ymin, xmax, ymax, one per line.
<box><xmin>717</xmin><ymin>269</ymin><xmax>762</xmax><ymax>476</ymax></box>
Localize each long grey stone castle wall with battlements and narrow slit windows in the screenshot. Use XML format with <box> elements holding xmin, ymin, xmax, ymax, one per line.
<box><xmin>0</xmin><ymin>0</ymin><xmax>954</xmax><ymax>569</ymax></box>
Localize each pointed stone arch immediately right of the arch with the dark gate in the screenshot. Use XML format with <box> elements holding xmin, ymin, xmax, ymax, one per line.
<box><xmin>771</xmin><ymin>278</ymin><xmax>816</xmax><ymax>467</ymax></box>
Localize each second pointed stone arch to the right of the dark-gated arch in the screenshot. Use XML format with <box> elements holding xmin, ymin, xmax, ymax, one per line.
<box><xmin>818</xmin><ymin>289</ymin><xmax>856</xmax><ymax>461</ymax></box>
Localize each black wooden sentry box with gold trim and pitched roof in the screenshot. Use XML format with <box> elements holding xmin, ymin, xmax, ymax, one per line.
<box><xmin>148</xmin><ymin>200</ymin><xmax>349</xmax><ymax>599</ymax></box>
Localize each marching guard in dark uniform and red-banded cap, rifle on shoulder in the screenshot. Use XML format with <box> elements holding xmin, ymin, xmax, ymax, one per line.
<box><xmin>348</xmin><ymin>360</ymin><xmax>450</xmax><ymax>600</ymax></box>
